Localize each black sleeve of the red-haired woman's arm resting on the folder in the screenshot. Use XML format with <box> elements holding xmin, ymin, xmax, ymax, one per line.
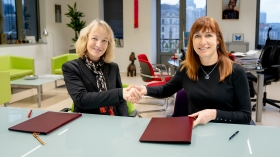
<box><xmin>214</xmin><ymin>64</ymin><xmax>251</xmax><ymax>124</ymax></box>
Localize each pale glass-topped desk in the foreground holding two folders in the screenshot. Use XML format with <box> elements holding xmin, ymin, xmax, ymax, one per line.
<box><xmin>0</xmin><ymin>107</ymin><xmax>280</xmax><ymax>157</ymax></box>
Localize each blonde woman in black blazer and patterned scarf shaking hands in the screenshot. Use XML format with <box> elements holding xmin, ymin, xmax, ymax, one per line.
<box><xmin>62</xmin><ymin>20</ymin><xmax>141</xmax><ymax>116</ymax></box>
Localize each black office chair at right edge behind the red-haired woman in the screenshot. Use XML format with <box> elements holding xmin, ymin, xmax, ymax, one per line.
<box><xmin>247</xmin><ymin>40</ymin><xmax>280</xmax><ymax>111</ymax></box>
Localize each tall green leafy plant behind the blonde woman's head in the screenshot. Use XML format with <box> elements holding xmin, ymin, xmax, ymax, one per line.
<box><xmin>65</xmin><ymin>2</ymin><xmax>86</xmax><ymax>42</ymax></box>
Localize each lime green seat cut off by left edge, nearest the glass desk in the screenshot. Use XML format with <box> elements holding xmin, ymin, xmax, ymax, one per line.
<box><xmin>0</xmin><ymin>72</ymin><xmax>11</xmax><ymax>106</ymax></box>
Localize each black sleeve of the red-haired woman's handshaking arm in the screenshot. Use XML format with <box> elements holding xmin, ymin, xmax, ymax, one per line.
<box><xmin>147</xmin><ymin>68</ymin><xmax>184</xmax><ymax>98</ymax></box>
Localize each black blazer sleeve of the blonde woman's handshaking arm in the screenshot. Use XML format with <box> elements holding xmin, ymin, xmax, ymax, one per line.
<box><xmin>62</xmin><ymin>60</ymin><xmax>125</xmax><ymax>111</ymax></box>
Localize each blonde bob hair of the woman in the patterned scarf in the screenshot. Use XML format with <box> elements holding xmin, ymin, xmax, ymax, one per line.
<box><xmin>76</xmin><ymin>19</ymin><xmax>115</xmax><ymax>63</ymax></box>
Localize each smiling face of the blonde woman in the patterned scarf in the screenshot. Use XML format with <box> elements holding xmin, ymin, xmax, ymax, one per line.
<box><xmin>86</xmin><ymin>25</ymin><xmax>109</xmax><ymax>62</ymax></box>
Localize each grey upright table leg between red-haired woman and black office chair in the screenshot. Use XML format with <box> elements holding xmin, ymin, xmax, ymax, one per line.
<box><xmin>256</xmin><ymin>73</ymin><xmax>264</xmax><ymax>122</ymax></box>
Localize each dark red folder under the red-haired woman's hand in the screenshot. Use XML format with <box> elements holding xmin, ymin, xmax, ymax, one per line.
<box><xmin>139</xmin><ymin>116</ymin><xmax>194</xmax><ymax>144</ymax></box>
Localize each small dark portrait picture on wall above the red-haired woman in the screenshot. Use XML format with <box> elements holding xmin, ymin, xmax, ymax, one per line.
<box><xmin>222</xmin><ymin>0</ymin><xmax>240</xmax><ymax>19</ymax></box>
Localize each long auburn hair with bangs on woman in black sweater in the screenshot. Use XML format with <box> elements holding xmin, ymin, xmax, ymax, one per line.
<box><xmin>180</xmin><ymin>16</ymin><xmax>233</xmax><ymax>81</ymax></box>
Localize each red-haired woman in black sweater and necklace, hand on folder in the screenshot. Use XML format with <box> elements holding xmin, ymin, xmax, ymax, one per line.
<box><xmin>131</xmin><ymin>17</ymin><xmax>251</xmax><ymax>127</ymax></box>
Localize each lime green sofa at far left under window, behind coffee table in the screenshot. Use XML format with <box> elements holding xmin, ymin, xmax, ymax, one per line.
<box><xmin>0</xmin><ymin>56</ymin><xmax>35</xmax><ymax>80</ymax></box>
